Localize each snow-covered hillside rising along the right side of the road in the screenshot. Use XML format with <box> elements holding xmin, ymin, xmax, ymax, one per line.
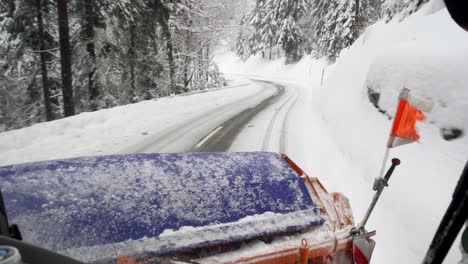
<box><xmin>218</xmin><ymin>1</ymin><xmax>468</xmax><ymax>263</ymax></box>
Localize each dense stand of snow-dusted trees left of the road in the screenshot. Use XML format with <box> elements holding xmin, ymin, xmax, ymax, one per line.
<box><xmin>0</xmin><ymin>0</ymin><xmax>230</xmax><ymax>131</ymax></box>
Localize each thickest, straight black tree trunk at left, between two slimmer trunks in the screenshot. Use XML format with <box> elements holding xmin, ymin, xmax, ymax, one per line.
<box><xmin>57</xmin><ymin>0</ymin><xmax>75</xmax><ymax>116</ymax></box>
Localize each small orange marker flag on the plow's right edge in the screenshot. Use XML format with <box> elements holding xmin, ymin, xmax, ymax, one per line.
<box><xmin>387</xmin><ymin>88</ymin><xmax>432</xmax><ymax>148</ymax></box>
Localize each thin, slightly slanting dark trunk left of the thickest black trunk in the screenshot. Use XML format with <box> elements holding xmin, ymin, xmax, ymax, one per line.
<box><xmin>36</xmin><ymin>0</ymin><xmax>55</xmax><ymax>121</ymax></box>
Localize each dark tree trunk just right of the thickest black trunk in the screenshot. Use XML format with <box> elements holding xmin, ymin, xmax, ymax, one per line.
<box><xmin>84</xmin><ymin>0</ymin><xmax>99</xmax><ymax>104</ymax></box>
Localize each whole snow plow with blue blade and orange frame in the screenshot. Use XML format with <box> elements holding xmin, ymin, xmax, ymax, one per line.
<box><xmin>0</xmin><ymin>152</ymin><xmax>375</xmax><ymax>264</ymax></box>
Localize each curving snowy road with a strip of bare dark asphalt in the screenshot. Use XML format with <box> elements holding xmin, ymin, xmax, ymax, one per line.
<box><xmin>115</xmin><ymin>77</ymin><xmax>304</xmax><ymax>156</ymax></box>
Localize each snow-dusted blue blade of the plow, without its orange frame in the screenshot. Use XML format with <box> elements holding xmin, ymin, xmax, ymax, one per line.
<box><xmin>0</xmin><ymin>152</ymin><xmax>323</xmax><ymax>261</ymax></box>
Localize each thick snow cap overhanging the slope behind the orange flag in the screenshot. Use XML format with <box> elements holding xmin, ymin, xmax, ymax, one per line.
<box><xmin>361</xmin><ymin>7</ymin><xmax>468</xmax><ymax>137</ymax></box>
